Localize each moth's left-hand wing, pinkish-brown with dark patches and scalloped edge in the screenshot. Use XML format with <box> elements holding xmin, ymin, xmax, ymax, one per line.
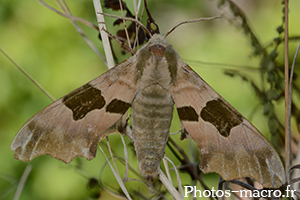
<box><xmin>11</xmin><ymin>56</ymin><xmax>137</xmax><ymax>163</ymax></box>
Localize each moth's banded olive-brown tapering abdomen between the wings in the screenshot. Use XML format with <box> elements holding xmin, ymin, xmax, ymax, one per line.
<box><xmin>132</xmin><ymin>84</ymin><xmax>174</xmax><ymax>181</ymax></box>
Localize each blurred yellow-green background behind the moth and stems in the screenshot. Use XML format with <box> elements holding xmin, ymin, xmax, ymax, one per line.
<box><xmin>0</xmin><ymin>0</ymin><xmax>300</xmax><ymax>199</ymax></box>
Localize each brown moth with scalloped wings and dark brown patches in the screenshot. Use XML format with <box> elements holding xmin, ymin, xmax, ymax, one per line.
<box><xmin>11</xmin><ymin>31</ymin><xmax>285</xmax><ymax>188</ymax></box>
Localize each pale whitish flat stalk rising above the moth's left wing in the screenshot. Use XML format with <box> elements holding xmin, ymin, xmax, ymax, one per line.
<box><xmin>93</xmin><ymin>0</ymin><xmax>115</xmax><ymax>69</ymax></box>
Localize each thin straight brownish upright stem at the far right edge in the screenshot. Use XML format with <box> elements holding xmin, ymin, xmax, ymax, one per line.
<box><xmin>284</xmin><ymin>0</ymin><xmax>291</xmax><ymax>172</ymax></box>
